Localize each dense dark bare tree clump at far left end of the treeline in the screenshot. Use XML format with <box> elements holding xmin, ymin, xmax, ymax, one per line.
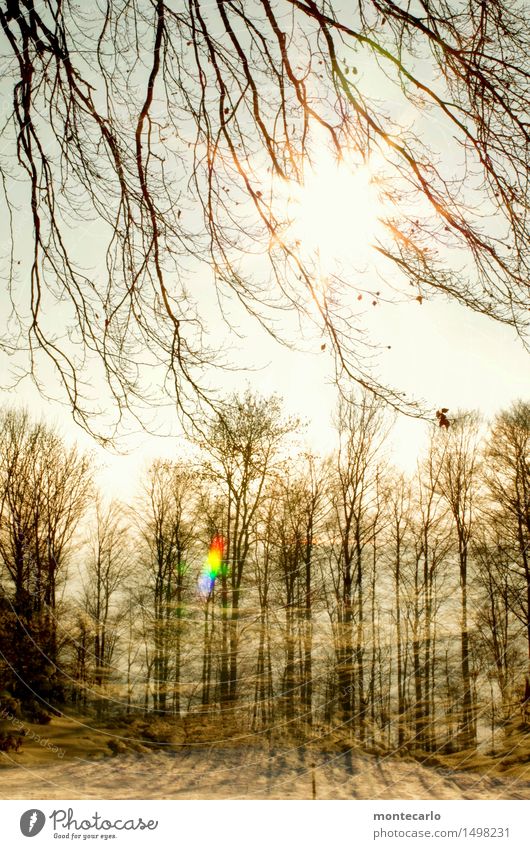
<box><xmin>0</xmin><ymin>411</ymin><xmax>92</xmax><ymax>702</ymax></box>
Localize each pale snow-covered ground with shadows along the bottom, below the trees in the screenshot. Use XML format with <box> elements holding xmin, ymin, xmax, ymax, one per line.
<box><xmin>0</xmin><ymin>747</ymin><xmax>530</xmax><ymax>799</ymax></box>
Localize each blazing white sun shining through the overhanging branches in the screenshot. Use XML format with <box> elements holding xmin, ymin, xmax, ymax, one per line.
<box><xmin>282</xmin><ymin>150</ymin><xmax>383</xmax><ymax>275</ymax></box>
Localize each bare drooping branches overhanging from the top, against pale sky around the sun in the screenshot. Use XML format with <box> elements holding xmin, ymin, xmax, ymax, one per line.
<box><xmin>0</xmin><ymin>0</ymin><xmax>530</xmax><ymax>439</ymax></box>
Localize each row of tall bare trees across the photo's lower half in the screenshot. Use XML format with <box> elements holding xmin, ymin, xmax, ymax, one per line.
<box><xmin>0</xmin><ymin>391</ymin><xmax>530</xmax><ymax>752</ymax></box>
